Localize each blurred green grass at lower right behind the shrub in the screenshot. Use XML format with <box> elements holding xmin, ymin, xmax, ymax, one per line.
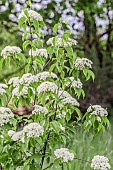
<box><xmin>49</xmin><ymin>120</ymin><xmax>113</xmax><ymax>170</ymax></box>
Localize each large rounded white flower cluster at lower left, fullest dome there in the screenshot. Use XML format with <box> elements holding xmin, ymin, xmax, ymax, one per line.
<box><xmin>23</xmin><ymin>123</ymin><xmax>44</xmax><ymax>137</ymax></box>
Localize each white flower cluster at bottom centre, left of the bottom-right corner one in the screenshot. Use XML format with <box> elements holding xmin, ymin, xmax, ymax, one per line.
<box><xmin>54</xmin><ymin>148</ymin><xmax>74</xmax><ymax>162</ymax></box>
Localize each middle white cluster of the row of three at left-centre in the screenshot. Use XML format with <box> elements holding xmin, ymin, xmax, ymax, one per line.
<box><xmin>19</xmin><ymin>73</ymin><xmax>35</xmax><ymax>84</ymax></box>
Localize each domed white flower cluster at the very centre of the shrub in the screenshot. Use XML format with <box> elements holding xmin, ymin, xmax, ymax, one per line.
<box><xmin>37</xmin><ymin>81</ymin><xmax>58</xmax><ymax>93</ymax></box>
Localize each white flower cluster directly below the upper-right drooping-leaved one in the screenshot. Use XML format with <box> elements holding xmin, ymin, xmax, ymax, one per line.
<box><xmin>66</xmin><ymin>77</ymin><xmax>82</xmax><ymax>88</ymax></box>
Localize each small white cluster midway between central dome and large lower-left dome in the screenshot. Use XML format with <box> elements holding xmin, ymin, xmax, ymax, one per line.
<box><xmin>32</xmin><ymin>105</ymin><xmax>48</xmax><ymax>114</ymax></box>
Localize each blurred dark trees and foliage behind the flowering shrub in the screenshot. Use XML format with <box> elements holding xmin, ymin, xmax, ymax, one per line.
<box><xmin>0</xmin><ymin>0</ymin><xmax>113</xmax><ymax>113</ymax></box>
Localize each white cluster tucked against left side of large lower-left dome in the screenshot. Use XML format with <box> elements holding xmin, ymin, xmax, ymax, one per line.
<box><xmin>12</xmin><ymin>130</ymin><xmax>24</xmax><ymax>142</ymax></box>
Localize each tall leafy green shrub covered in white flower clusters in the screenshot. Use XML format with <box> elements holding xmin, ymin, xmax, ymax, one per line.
<box><xmin>0</xmin><ymin>2</ymin><xmax>110</xmax><ymax>170</ymax></box>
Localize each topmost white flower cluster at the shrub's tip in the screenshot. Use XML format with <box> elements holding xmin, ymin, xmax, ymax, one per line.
<box><xmin>18</xmin><ymin>10</ymin><xmax>43</xmax><ymax>21</ymax></box>
